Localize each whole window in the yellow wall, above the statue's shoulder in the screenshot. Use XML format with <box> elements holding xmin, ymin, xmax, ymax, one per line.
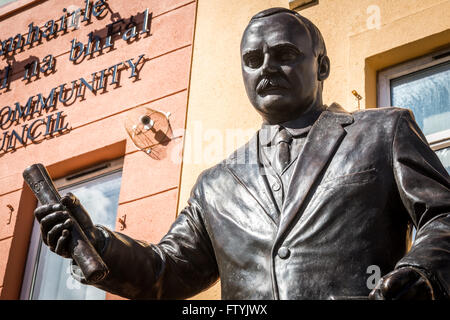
<box><xmin>378</xmin><ymin>49</ymin><xmax>450</xmax><ymax>172</ymax></box>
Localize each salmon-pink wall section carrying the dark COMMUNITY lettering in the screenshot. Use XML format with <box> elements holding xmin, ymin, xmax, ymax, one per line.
<box><xmin>0</xmin><ymin>0</ymin><xmax>197</xmax><ymax>299</ymax></box>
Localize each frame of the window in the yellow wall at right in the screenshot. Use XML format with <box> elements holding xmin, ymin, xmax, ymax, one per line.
<box><xmin>377</xmin><ymin>48</ymin><xmax>450</xmax><ymax>151</ymax></box>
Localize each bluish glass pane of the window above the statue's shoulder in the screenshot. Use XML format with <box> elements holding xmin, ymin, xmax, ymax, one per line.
<box><xmin>391</xmin><ymin>62</ymin><xmax>450</xmax><ymax>135</ymax></box>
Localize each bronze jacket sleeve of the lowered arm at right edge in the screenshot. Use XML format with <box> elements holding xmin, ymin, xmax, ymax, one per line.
<box><xmin>392</xmin><ymin>111</ymin><xmax>450</xmax><ymax>298</ymax></box>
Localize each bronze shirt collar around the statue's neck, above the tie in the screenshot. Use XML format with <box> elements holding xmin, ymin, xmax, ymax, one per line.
<box><xmin>259</xmin><ymin>106</ymin><xmax>326</xmax><ymax>145</ymax></box>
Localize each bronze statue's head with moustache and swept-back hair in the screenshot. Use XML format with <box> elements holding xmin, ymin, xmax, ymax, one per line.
<box><xmin>241</xmin><ymin>8</ymin><xmax>330</xmax><ymax>123</ymax></box>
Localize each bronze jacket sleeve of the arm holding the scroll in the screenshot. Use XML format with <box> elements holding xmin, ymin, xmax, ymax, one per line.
<box><xmin>72</xmin><ymin>180</ymin><xmax>218</xmax><ymax>299</ymax></box>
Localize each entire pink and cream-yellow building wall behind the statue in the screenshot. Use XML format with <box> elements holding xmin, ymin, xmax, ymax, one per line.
<box><xmin>0</xmin><ymin>0</ymin><xmax>450</xmax><ymax>299</ymax></box>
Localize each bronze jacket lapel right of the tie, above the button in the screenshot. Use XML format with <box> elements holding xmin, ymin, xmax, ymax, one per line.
<box><xmin>277</xmin><ymin>104</ymin><xmax>353</xmax><ymax>242</ymax></box>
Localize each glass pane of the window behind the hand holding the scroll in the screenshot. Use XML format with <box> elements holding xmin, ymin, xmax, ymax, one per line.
<box><xmin>32</xmin><ymin>172</ymin><xmax>122</xmax><ymax>300</ymax></box>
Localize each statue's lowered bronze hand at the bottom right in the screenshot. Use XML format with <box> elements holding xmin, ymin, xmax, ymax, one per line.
<box><xmin>369</xmin><ymin>267</ymin><xmax>434</xmax><ymax>300</ymax></box>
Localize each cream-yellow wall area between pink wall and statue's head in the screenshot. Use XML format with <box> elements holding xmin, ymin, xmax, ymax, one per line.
<box><xmin>178</xmin><ymin>0</ymin><xmax>288</xmax><ymax>299</ymax></box>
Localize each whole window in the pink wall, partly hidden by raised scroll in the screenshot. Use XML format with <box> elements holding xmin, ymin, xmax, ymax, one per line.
<box><xmin>21</xmin><ymin>159</ymin><xmax>123</xmax><ymax>300</ymax></box>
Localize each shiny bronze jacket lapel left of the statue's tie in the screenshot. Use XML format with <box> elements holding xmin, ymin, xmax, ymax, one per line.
<box><xmin>227</xmin><ymin>133</ymin><xmax>279</xmax><ymax>226</ymax></box>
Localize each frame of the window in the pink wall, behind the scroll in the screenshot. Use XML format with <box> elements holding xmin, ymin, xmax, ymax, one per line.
<box><xmin>20</xmin><ymin>158</ymin><xmax>124</xmax><ymax>300</ymax></box>
